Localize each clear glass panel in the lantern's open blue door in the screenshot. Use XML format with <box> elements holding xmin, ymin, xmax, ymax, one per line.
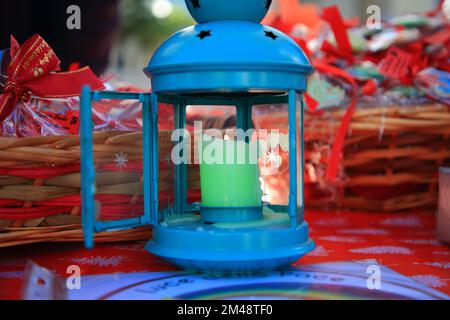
<box><xmin>92</xmin><ymin>99</ymin><xmax>144</xmax><ymax>225</ymax></box>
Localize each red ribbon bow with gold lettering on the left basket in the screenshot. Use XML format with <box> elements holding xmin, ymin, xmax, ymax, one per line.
<box><xmin>0</xmin><ymin>34</ymin><xmax>104</xmax><ymax>123</ymax></box>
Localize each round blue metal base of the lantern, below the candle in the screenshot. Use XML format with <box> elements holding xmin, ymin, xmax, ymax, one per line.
<box><xmin>146</xmin><ymin>221</ymin><xmax>315</xmax><ymax>274</ymax></box>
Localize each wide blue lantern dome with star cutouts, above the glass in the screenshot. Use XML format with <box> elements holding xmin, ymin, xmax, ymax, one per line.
<box><xmin>144</xmin><ymin>20</ymin><xmax>313</xmax><ymax>93</ymax></box>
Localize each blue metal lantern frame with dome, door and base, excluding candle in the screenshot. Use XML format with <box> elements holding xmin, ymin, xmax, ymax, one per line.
<box><xmin>80</xmin><ymin>0</ymin><xmax>315</xmax><ymax>273</ymax></box>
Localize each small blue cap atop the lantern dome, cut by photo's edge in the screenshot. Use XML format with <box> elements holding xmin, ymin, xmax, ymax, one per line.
<box><xmin>185</xmin><ymin>0</ymin><xmax>272</xmax><ymax>23</ymax></box>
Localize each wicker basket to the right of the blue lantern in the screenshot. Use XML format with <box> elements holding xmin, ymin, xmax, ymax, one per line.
<box><xmin>255</xmin><ymin>104</ymin><xmax>450</xmax><ymax>212</ymax></box>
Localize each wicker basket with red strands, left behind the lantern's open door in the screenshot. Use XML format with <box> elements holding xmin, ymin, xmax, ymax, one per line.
<box><xmin>0</xmin><ymin>131</ymin><xmax>199</xmax><ymax>247</ymax></box>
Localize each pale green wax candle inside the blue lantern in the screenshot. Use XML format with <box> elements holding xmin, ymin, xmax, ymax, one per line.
<box><xmin>199</xmin><ymin>135</ymin><xmax>262</xmax><ymax>207</ymax></box>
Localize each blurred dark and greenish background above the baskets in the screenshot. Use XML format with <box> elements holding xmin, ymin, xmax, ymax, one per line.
<box><xmin>0</xmin><ymin>0</ymin><xmax>438</xmax><ymax>88</ymax></box>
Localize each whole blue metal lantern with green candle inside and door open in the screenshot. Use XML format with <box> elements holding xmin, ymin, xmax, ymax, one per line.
<box><xmin>81</xmin><ymin>0</ymin><xmax>315</xmax><ymax>273</ymax></box>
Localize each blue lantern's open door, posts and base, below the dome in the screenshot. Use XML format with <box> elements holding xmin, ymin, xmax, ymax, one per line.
<box><xmin>81</xmin><ymin>87</ymin><xmax>314</xmax><ymax>272</ymax></box>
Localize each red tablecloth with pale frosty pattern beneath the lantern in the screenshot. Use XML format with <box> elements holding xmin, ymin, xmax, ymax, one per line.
<box><xmin>0</xmin><ymin>211</ymin><xmax>450</xmax><ymax>299</ymax></box>
